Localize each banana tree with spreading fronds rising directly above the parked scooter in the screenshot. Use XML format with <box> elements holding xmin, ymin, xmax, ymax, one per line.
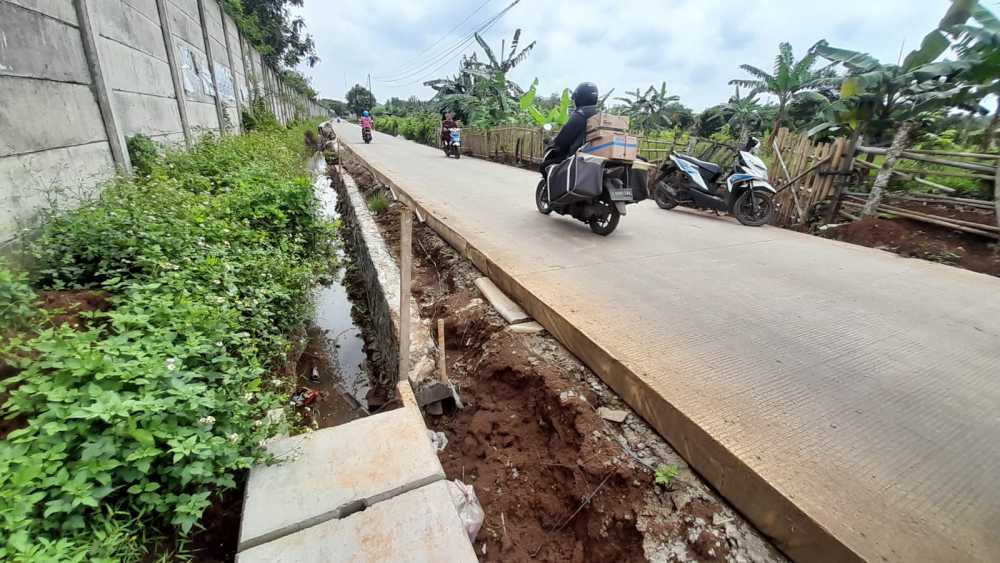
<box><xmin>729</xmin><ymin>43</ymin><xmax>834</xmax><ymax>137</ymax></box>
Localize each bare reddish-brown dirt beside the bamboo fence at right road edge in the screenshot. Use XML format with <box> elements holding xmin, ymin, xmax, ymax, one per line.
<box><xmin>823</xmin><ymin>218</ymin><xmax>1000</xmax><ymax>276</ymax></box>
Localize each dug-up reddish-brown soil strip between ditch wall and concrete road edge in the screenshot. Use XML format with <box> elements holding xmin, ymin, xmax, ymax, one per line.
<box><xmin>345</xmin><ymin>156</ymin><xmax>783</xmax><ymax>562</ymax></box>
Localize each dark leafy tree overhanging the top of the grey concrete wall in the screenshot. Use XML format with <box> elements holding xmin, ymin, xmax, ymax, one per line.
<box><xmin>223</xmin><ymin>0</ymin><xmax>319</xmax><ymax>68</ymax></box>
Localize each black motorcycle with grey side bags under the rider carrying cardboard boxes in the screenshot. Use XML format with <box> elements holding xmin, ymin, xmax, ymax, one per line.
<box><xmin>535</xmin><ymin>125</ymin><xmax>647</xmax><ymax>236</ymax></box>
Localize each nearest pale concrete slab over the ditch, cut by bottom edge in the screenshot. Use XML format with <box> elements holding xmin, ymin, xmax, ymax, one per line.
<box><xmin>236</xmin><ymin>481</ymin><xmax>476</xmax><ymax>563</ymax></box>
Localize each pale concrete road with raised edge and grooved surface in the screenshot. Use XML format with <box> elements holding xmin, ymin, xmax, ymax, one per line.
<box><xmin>339</xmin><ymin>126</ymin><xmax>1000</xmax><ymax>561</ymax></box>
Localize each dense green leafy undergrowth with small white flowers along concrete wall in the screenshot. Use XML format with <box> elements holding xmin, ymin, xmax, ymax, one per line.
<box><xmin>0</xmin><ymin>124</ymin><xmax>333</xmax><ymax>561</ymax></box>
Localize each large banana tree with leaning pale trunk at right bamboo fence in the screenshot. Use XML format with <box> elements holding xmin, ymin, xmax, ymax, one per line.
<box><xmin>814</xmin><ymin>0</ymin><xmax>978</xmax><ymax>217</ymax></box>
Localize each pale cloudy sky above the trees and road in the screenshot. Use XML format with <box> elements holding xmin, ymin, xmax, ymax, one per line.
<box><xmin>295</xmin><ymin>0</ymin><xmax>950</xmax><ymax>110</ymax></box>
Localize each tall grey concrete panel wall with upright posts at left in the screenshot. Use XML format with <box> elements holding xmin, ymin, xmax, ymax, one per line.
<box><xmin>0</xmin><ymin>0</ymin><xmax>327</xmax><ymax>247</ymax></box>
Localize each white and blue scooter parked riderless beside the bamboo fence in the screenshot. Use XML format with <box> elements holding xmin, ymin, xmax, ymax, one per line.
<box><xmin>653</xmin><ymin>139</ymin><xmax>777</xmax><ymax>227</ymax></box>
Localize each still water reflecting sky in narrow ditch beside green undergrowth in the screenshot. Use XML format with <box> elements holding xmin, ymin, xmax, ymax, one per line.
<box><xmin>298</xmin><ymin>161</ymin><xmax>370</xmax><ymax>428</ymax></box>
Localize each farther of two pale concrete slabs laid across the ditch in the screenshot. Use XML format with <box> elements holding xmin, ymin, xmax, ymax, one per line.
<box><xmin>239</xmin><ymin>408</ymin><xmax>444</xmax><ymax>551</ymax></box>
